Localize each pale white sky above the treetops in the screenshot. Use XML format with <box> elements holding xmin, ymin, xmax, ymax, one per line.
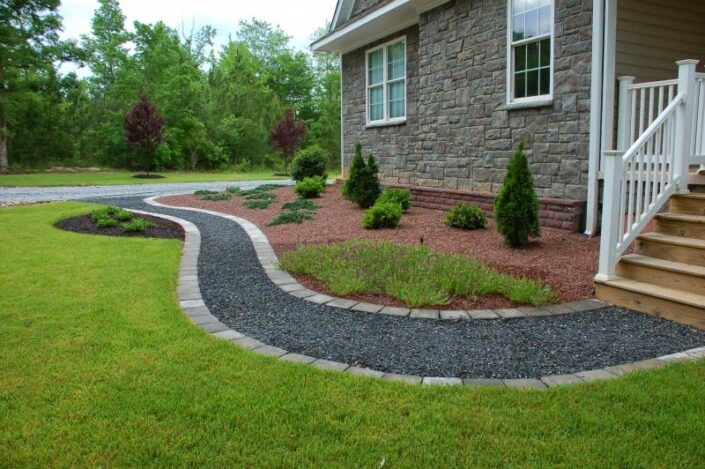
<box><xmin>59</xmin><ymin>0</ymin><xmax>336</xmax><ymax>50</ymax></box>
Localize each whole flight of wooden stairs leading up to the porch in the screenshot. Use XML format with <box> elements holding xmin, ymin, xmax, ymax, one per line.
<box><xmin>595</xmin><ymin>193</ymin><xmax>705</xmax><ymax>329</ymax></box>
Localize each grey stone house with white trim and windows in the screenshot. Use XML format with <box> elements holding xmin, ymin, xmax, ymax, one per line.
<box><xmin>313</xmin><ymin>0</ymin><xmax>705</xmax><ymax>235</ymax></box>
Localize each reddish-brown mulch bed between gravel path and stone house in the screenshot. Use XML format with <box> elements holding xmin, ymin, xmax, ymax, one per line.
<box><xmin>159</xmin><ymin>187</ymin><xmax>599</xmax><ymax>309</ymax></box>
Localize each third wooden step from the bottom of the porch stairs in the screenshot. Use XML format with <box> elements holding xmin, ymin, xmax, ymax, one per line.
<box><xmin>636</xmin><ymin>233</ymin><xmax>705</xmax><ymax>267</ymax></box>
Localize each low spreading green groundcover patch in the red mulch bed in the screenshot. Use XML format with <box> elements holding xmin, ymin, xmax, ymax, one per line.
<box><xmin>281</xmin><ymin>241</ymin><xmax>556</xmax><ymax>307</ymax></box>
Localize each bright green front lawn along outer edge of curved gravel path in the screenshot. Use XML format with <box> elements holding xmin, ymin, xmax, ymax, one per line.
<box><xmin>0</xmin><ymin>203</ymin><xmax>705</xmax><ymax>467</ymax></box>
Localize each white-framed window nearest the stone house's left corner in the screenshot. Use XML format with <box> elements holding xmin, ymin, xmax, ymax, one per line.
<box><xmin>367</xmin><ymin>38</ymin><xmax>406</xmax><ymax>124</ymax></box>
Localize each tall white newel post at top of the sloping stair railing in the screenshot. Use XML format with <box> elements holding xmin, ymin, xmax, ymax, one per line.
<box><xmin>673</xmin><ymin>59</ymin><xmax>699</xmax><ymax>193</ymax></box>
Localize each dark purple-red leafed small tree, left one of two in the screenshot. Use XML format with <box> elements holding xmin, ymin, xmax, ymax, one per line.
<box><xmin>124</xmin><ymin>95</ymin><xmax>166</xmax><ymax>176</ymax></box>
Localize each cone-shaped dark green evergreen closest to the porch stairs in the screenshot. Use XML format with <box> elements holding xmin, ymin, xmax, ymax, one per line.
<box><xmin>494</xmin><ymin>143</ymin><xmax>541</xmax><ymax>248</ymax></box>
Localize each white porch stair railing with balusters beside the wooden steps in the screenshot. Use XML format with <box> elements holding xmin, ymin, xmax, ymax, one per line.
<box><xmin>597</xmin><ymin>60</ymin><xmax>705</xmax><ymax>280</ymax></box>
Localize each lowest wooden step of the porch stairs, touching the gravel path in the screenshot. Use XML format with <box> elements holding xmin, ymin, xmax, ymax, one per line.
<box><xmin>595</xmin><ymin>277</ymin><xmax>705</xmax><ymax>329</ymax></box>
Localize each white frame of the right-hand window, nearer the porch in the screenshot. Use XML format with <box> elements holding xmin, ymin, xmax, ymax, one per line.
<box><xmin>507</xmin><ymin>0</ymin><xmax>556</xmax><ymax>107</ymax></box>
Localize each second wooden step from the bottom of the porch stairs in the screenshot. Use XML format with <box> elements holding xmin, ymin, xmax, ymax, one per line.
<box><xmin>617</xmin><ymin>254</ymin><xmax>705</xmax><ymax>294</ymax></box>
